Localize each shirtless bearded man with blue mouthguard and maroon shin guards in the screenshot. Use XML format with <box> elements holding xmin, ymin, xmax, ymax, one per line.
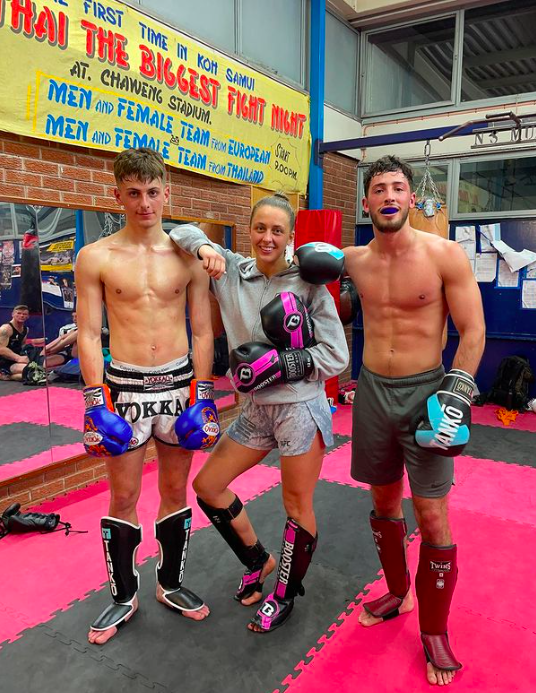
<box><xmin>344</xmin><ymin>156</ymin><xmax>485</xmax><ymax>685</ymax></box>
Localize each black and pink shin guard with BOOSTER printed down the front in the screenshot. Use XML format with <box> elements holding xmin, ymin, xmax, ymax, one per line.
<box><xmin>251</xmin><ymin>517</ymin><xmax>318</xmax><ymax>632</ymax></box>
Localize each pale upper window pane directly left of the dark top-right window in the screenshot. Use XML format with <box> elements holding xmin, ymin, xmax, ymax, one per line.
<box><xmin>365</xmin><ymin>17</ymin><xmax>456</xmax><ymax>113</ymax></box>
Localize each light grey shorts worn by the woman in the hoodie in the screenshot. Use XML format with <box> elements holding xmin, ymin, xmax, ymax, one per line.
<box><xmin>227</xmin><ymin>392</ymin><xmax>333</xmax><ymax>457</ymax></box>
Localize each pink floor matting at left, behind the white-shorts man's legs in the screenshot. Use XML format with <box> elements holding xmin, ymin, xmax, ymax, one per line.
<box><xmin>0</xmin><ymin>453</ymin><xmax>280</xmax><ymax>642</ymax></box>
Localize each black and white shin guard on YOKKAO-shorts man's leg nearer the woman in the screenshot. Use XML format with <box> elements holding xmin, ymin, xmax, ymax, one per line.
<box><xmin>154</xmin><ymin>507</ymin><xmax>204</xmax><ymax>611</ymax></box>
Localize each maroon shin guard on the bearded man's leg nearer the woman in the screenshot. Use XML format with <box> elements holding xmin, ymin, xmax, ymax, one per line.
<box><xmin>363</xmin><ymin>511</ymin><xmax>410</xmax><ymax>621</ymax></box>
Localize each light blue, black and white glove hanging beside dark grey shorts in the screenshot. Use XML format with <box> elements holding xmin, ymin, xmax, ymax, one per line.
<box><xmin>415</xmin><ymin>368</ymin><xmax>475</xmax><ymax>457</ymax></box>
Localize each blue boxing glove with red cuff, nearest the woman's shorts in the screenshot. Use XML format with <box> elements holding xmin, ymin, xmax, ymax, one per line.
<box><xmin>175</xmin><ymin>380</ymin><xmax>220</xmax><ymax>450</ymax></box>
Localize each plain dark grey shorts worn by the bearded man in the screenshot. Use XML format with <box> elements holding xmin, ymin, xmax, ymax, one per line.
<box><xmin>352</xmin><ymin>366</ymin><xmax>454</xmax><ymax>498</ymax></box>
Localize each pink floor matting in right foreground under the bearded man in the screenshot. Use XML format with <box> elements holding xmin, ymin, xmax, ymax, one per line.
<box><xmin>283</xmin><ymin>510</ymin><xmax>536</xmax><ymax>693</ymax></box>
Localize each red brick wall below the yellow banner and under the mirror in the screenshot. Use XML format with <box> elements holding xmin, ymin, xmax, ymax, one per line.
<box><xmin>0</xmin><ymin>133</ymin><xmax>357</xmax><ymax>510</ymax></box>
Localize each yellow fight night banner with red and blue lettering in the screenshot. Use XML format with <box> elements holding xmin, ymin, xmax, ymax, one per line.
<box><xmin>0</xmin><ymin>0</ymin><xmax>311</xmax><ymax>193</ymax></box>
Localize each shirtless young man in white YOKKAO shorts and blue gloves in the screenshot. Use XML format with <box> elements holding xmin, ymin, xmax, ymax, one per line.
<box><xmin>76</xmin><ymin>148</ymin><xmax>219</xmax><ymax>645</ymax></box>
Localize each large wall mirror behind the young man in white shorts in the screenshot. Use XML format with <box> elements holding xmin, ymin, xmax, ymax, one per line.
<box><xmin>0</xmin><ymin>203</ymin><xmax>236</xmax><ymax>481</ymax></box>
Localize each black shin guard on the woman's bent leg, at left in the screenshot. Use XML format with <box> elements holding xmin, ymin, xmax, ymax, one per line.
<box><xmin>197</xmin><ymin>496</ymin><xmax>270</xmax><ymax>601</ymax></box>
